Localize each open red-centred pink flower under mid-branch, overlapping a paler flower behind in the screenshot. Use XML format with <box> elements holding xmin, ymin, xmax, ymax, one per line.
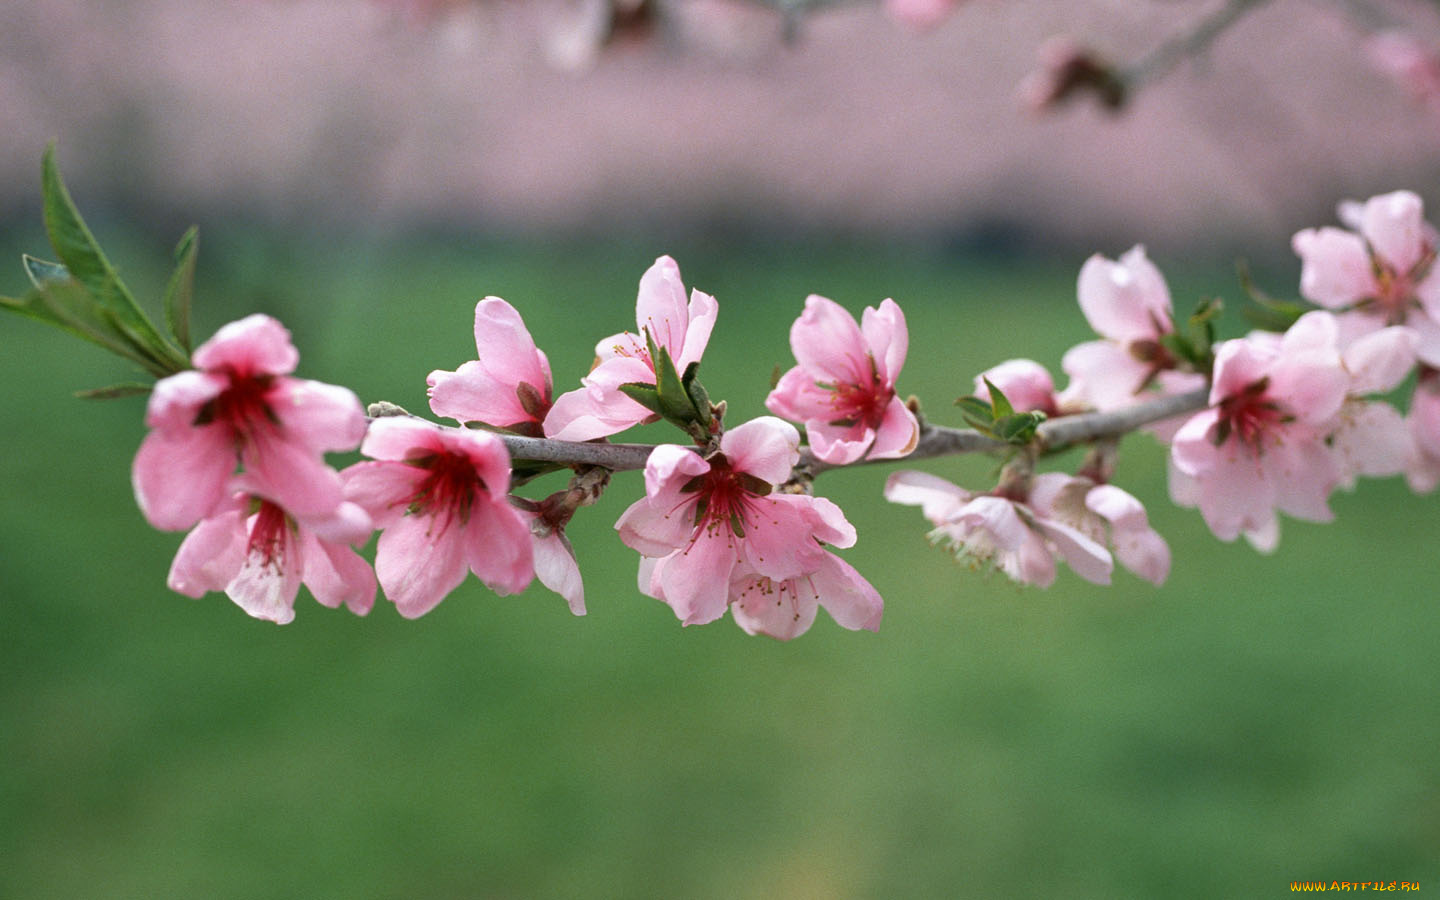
<box><xmin>615</xmin><ymin>416</ymin><xmax>855</xmax><ymax>625</ymax></box>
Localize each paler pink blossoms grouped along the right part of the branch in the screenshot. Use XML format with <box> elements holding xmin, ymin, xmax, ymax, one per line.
<box><xmin>886</xmin><ymin>192</ymin><xmax>1440</xmax><ymax>585</ymax></box>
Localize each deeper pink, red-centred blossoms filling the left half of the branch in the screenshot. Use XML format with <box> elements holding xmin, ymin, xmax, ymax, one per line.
<box><xmin>134</xmin><ymin>258</ymin><xmax>898</xmax><ymax>639</ymax></box>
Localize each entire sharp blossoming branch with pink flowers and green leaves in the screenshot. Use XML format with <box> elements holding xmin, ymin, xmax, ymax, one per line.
<box><xmin>19</xmin><ymin>145</ymin><xmax>1440</xmax><ymax>630</ymax></box>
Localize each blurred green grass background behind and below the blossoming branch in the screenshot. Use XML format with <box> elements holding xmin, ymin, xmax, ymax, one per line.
<box><xmin>0</xmin><ymin>218</ymin><xmax>1440</xmax><ymax>899</ymax></box>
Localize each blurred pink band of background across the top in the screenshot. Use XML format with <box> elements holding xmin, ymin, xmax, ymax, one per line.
<box><xmin>0</xmin><ymin>0</ymin><xmax>1440</xmax><ymax>249</ymax></box>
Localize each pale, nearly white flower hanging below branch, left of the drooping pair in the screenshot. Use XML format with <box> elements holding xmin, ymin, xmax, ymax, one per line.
<box><xmin>886</xmin><ymin>471</ymin><xmax>1115</xmax><ymax>588</ymax></box>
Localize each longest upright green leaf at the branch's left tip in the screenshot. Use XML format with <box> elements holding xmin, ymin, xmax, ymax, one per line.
<box><xmin>40</xmin><ymin>144</ymin><xmax>190</xmax><ymax>374</ymax></box>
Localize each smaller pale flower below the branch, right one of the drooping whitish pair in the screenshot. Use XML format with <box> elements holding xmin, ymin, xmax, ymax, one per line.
<box><xmin>1030</xmin><ymin>472</ymin><xmax>1171</xmax><ymax>585</ymax></box>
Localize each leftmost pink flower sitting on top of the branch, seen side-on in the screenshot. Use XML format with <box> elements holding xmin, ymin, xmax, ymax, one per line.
<box><xmin>425</xmin><ymin>297</ymin><xmax>552</xmax><ymax>438</ymax></box>
